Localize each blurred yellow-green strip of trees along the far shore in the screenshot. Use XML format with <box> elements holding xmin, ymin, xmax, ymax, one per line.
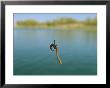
<box><xmin>16</xmin><ymin>17</ymin><xmax>97</xmax><ymax>27</ymax></box>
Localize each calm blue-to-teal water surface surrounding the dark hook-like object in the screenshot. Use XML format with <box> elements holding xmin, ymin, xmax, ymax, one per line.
<box><xmin>13</xmin><ymin>29</ymin><xmax>97</xmax><ymax>75</ymax></box>
